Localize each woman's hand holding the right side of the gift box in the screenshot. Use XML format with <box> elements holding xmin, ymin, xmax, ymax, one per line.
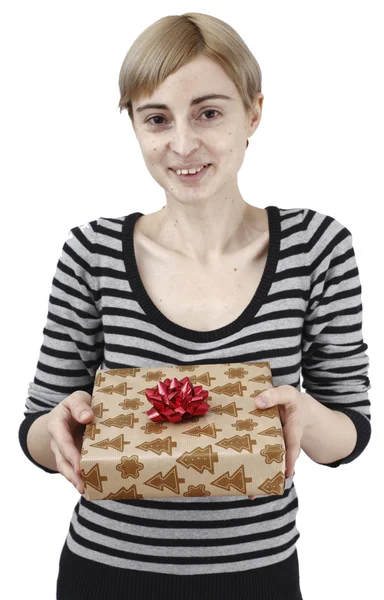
<box><xmin>248</xmin><ymin>385</ymin><xmax>306</xmax><ymax>500</ymax></box>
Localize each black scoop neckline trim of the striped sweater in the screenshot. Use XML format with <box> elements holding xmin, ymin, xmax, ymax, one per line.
<box><xmin>122</xmin><ymin>206</ymin><xmax>281</xmax><ymax>342</ymax></box>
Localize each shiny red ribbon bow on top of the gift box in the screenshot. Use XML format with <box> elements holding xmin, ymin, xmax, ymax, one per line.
<box><xmin>145</xmin><ymin>377</ymin><xmax>209</xmax><ymax>423</ymax></box>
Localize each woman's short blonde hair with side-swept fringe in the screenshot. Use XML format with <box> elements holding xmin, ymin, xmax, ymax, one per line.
<box><xmin>118</xmin><ymin>13</ymin><xmax>261</xmax><ymax>121</ymax></box>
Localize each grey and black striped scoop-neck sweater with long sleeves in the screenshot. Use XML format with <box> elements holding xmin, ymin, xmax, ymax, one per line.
<box><xmin>19</xmin><ymin>206</ymin><xmax>371</xmax><ymax>584</ymax></box>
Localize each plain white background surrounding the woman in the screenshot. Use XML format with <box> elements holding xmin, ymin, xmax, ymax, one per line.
<box><xmin>0</xmin><ymin>0</ymin><xmax>384</xmax><ymax>600</ymax></box>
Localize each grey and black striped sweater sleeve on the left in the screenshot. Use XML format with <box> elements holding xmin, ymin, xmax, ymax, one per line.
<box><xmin>19</xmin><ymin>221</ymin><xmax>104</xmax><ymax>473</ymax></box>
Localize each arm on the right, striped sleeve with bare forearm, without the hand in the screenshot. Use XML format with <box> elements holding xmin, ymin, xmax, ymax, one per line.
<box><xmin>301</xmin><ymin>213</ymin><xmax>371</xmax><ymax>467</ymax></box>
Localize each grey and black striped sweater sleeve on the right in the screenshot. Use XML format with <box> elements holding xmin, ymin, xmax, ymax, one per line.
<box><xmin>301</xmin><ymin>213</ymin><xmax>371</xmax><ymax>467</ymax></box>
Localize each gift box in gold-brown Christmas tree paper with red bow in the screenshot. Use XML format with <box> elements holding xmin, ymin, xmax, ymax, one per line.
<box><xmin>80</xmin><ymin>362</ymin><xmax>286</xmax><ymax>500</ymax></box>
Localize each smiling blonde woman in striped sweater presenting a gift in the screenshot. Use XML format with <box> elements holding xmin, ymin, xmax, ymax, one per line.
<box><xmin>20</xmin><ymin>13</ymin><xmax>370</xmax><ymax>600</ymax></box>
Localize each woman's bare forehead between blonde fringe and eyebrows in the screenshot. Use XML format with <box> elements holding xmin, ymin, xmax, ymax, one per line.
<box><xmin>132</xmin><ymin>56</ymin><xmax>240</xmax><ymax>112</ymax></box>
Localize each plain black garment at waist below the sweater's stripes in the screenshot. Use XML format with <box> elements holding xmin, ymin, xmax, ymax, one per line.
<box><xmin>56</xmin><ymin>542</ymin><xmax>302</xmax><ymax>600</ymax></box>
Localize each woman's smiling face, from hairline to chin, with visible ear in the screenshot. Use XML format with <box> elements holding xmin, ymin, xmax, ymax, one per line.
<box><xmin>132</xmin><ymin>56</ymin><xmax>263</xmax><ymax>202</ymax></box>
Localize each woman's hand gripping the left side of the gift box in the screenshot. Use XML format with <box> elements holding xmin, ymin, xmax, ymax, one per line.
<box><xmin>47</xmin><ymin>390</ymin><xmax>94</xmax><ymax>494</ymax></box>
